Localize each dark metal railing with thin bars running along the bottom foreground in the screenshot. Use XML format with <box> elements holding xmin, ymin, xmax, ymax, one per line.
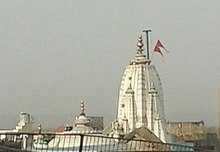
<box><xmin>0</xmin><ymin>133</ymin><xmax>210</xmax><ymax>152</ymax></box>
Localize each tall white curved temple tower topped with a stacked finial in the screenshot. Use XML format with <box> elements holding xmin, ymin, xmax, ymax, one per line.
<box><xmin>117</xmin><ymin>33</ymin><xmax>170</xmax><ymax>142</ymax></box>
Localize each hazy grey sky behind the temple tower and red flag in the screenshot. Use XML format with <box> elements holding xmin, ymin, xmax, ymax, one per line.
<box><xmin>0</xmin><ymin>0</ymin><xmax>220</xmax><ymax>128</ymax></box>
